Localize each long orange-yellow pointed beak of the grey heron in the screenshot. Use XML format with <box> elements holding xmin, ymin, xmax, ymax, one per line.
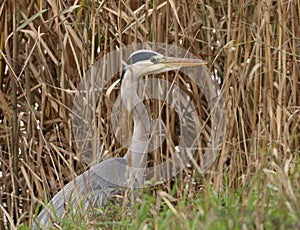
<box><xmin>161</xmin><ymin>57</ymin><xmax>208</xmax><ymax>68</ymax></box>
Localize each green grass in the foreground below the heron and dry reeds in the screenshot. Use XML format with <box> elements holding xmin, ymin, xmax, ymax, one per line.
<box><xmin>27</xmin><ymin>158</ymin><xmax>300</xmax><ymax>230</ymax></box>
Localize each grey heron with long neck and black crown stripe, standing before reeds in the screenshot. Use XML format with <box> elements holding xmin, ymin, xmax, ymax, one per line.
<box><xmin>33</xmin><ymin>50</ymin><xmax>206</xmax><ymax>228</ymax></box>
